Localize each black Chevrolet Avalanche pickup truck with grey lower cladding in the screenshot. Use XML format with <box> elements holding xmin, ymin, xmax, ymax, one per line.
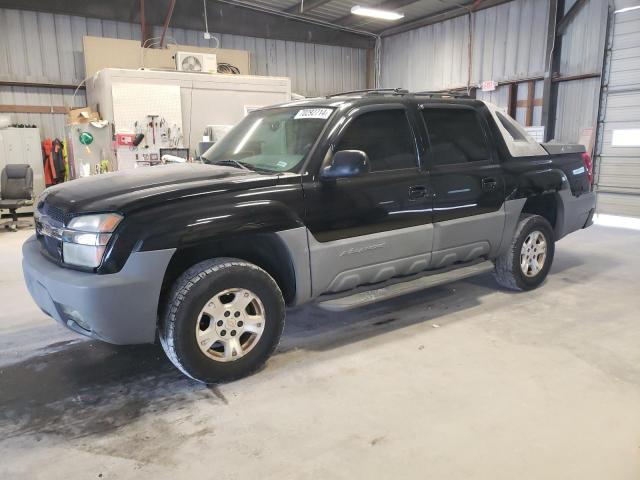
<box><xmin>23</xmin><ymin>91</ymin><xmax>595</xmax><ymax>382</ymax></box>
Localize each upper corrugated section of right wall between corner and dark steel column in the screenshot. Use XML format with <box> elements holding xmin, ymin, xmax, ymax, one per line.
<box><xmin>381</xmin><ymin>0</ymin><xmax>548</xmax><ymax>90</ymax></box>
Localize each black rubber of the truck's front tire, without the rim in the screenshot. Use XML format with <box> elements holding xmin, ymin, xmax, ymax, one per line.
<box><xmin>159</xmin><ymin>258</ymin><xmax>285</xmax><ymax>383</ymax></box>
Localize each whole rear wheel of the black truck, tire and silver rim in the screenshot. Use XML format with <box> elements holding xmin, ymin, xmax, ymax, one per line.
<box><xmin>493</xmin><ymin>213</ymin><xmax>555</xmax><ymax>291</ymax></box>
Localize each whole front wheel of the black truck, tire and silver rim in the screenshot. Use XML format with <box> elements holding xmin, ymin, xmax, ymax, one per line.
<box><xmin>160</xmin><ymin>258</ymin><xmax>285</xmax><ymax>383</ymax></box>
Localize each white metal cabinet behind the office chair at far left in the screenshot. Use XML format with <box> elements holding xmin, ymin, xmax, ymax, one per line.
<box><xmin>0</xmin><ymin>128</ymin><xmax>45</xmax><ymax>213</ymax></box>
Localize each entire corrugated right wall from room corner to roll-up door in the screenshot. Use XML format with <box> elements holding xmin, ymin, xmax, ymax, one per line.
<box><xmin>380</xmin><ymin>0</ymin><xmax>608</xmax><ymax>142</ymax></box>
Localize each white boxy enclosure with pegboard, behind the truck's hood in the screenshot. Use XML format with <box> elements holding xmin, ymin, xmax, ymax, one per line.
<box><xmin>87</xmin><ymin>68</ymin><xmax>291</xmax><ymax>168</ymax></box>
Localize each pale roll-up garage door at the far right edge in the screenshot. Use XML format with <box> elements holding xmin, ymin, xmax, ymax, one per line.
<box><xmin>596</xmin><ymin>0</ymin><xmax>640</xmax><ymax>217</ymax></box>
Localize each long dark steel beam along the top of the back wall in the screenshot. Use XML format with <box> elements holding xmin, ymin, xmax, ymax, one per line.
<box><xmin>0</xmin><ymin>0</ymin><xmax>375</xmax><ymax>48</ymax></box>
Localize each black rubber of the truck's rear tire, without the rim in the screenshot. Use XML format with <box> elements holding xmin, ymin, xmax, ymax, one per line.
<box><xmin>493</xmin><ymin>213</ymin><xmax>555</xmax><ymax>291</ymax></box>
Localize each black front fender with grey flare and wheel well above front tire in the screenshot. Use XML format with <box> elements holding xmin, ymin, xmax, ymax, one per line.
<box><xmin>122</xmin><ymin>200</ymin><xmax>310</xmax><ymax>304</ymax></box>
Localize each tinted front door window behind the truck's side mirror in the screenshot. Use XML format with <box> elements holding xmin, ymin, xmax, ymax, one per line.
<box><xmin>336</xmin><ymin>110</ymin><xmax>418</xmax><ymax>172</ymax></box>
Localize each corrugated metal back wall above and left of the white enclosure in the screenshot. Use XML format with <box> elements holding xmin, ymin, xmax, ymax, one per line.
<box><xmin>0</xmin><ymin>9</ymin><xmax>366</xmax><ymax>137</ymax></box>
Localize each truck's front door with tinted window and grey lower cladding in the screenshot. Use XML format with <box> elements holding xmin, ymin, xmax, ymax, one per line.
<box><xmin>303</xmin><ymin>104</ymin><xmax>433</xmax><ymax>296</ymax></box>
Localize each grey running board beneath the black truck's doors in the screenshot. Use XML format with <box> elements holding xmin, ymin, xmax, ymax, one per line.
<box><xmin>317</xmin><ymin>261</ymin><xmax>494</xmax><ymax>312</ymax></box>
